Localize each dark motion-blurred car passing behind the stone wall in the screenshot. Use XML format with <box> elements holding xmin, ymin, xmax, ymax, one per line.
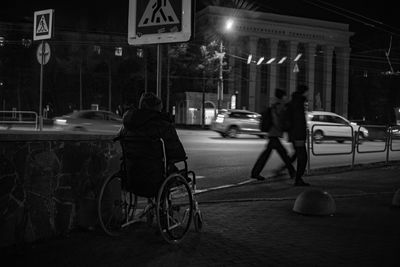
<box><xmin>53</xmin><ymin>110</ymin><xmax>122</xmax><ymax>133</ymax></box>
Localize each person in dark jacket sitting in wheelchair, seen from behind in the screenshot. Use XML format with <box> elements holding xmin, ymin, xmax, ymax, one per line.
<box><xmin>119</xmin><ymin>93</ymin><xmax>187</xmax><ymax>197</ymax></box>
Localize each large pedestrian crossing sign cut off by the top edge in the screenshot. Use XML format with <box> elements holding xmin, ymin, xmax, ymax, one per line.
<box><xmin>128</xmin><ymin>0</ymin><xmax>192</xmax><ymax>45</ymax></box>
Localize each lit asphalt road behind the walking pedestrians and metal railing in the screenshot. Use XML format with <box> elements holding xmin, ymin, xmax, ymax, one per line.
<box><xmin>0</xmin><ymin>127</ymin><xmax>400</xmax><ymax>190</ymax></box>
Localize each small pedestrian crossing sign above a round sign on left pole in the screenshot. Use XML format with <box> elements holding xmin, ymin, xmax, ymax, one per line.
<box><xmin>33</xmin><ymin>9</ymin><xmax>54</xmax><ymax>41</ymax></box>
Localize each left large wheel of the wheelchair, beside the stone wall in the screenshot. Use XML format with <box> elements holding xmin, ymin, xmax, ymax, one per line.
<box><xmin>97</xmin><ymin>174</ymin><xmax>137</xmax><ymax>236</ymax></box>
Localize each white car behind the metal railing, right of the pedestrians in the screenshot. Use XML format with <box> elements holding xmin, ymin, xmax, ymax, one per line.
<box><xmin>306</xmin><ymin>111</ymin><xmax>368</xmax><ymax>143</ymax></box>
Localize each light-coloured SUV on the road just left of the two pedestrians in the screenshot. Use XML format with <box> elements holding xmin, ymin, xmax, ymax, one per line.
<box><xmin>210</xmin><ymin>109</ymin><xmax>265</xmax><ymax>138</ymax></box>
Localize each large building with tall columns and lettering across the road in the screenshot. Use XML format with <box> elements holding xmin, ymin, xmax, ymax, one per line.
<box><xmin>196</xmin><ymin>6</ymin><xmax>353</xmax><ymax>116</ymax></box>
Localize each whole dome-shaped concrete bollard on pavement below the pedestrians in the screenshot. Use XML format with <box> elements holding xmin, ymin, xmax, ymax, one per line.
<box><xmin>293</xmin><ymin>189</ymin><xmax>336</xmax><ymax>216</ymax></box>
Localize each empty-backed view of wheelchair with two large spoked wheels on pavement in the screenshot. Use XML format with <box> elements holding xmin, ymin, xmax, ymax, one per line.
<box><xmin>97</xmin><ymin>137</ymin><xmax>203</xmax><ymax>244</ymax></box>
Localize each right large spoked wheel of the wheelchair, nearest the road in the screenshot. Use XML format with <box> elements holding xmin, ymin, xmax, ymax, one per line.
<box><xmin>156</xmin><ymin>174</ymin><xmax>193</xmax><ymax>244</ymax></box>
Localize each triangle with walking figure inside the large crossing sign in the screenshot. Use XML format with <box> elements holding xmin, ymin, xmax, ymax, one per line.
<box><xmin>138</xmin><ymin>0</ymin><xmax>180</xmax><ymax>27</ymax></box>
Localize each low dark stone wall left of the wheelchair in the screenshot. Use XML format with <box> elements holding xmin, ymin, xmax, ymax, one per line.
<box><xmin>0</xmin><ymin>131</ymin><xmax>121</xmax><ymax>247</ymax></box>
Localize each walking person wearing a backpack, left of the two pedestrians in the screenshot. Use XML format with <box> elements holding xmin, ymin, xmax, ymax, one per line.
<box><xmin>251</xmin><ymin>88</ymin><xmax>296</xmax><ymax>180</ymax></box>
